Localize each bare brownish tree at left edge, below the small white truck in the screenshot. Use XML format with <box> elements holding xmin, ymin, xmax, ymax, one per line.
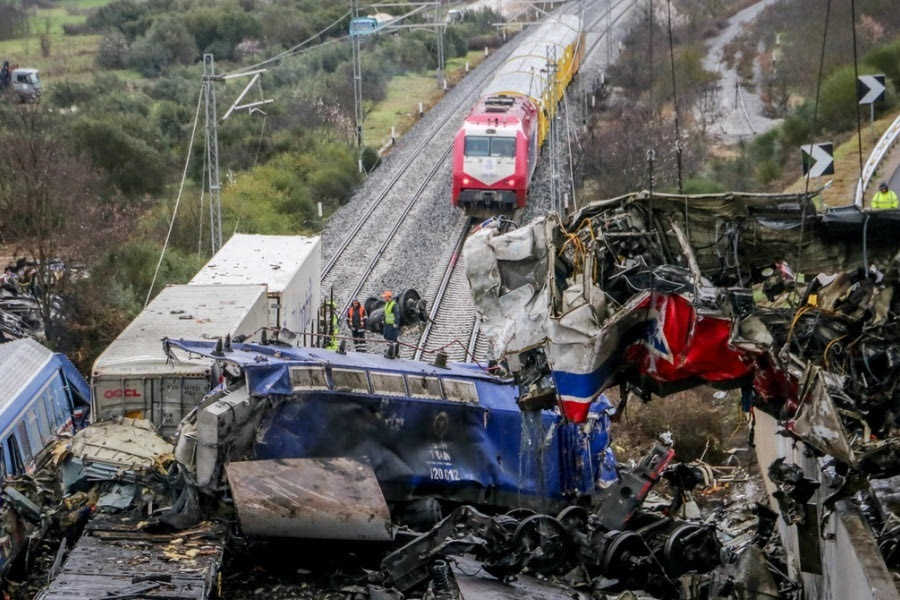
<box><xmin>0</xmin><ymin>105</ymin><xmax>135</xmax><ymax>332</ymax></box>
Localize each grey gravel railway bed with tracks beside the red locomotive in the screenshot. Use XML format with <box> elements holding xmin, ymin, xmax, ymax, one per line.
<box><xmin>321</xmin><ymin>0</ymin><xmax>636</xmax><ymax>361</ymax></box>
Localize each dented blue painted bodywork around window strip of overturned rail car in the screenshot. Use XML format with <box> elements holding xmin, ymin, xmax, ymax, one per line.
<box><xmin>170</xmin><ymin>341</ymin><xmax>616</xmax><ymax>508</ymax></box>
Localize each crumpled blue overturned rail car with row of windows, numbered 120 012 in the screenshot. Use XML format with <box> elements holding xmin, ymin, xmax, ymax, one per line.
<box><xmin>164</xmin><ymin>340</ymin><xmax>617</xmax><ymax>537</ymax></box>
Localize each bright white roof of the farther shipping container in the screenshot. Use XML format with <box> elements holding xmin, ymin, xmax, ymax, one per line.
<box><xmin>189</xmin><ymin>233</ymin><xmax>319</xmax><ymax>293</ymax></box>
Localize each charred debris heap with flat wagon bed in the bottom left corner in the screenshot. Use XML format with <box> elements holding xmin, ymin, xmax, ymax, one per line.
<box><xmin>0</xmin><ymin>419</ymin><xmax>226</xmax><ymax>600</ymax></box>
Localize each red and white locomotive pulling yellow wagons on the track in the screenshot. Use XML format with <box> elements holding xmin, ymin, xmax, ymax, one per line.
<box><xmin>451</xmin><ymin>15</ymin><xmax>584</xmax><ymax>213</ymax></box>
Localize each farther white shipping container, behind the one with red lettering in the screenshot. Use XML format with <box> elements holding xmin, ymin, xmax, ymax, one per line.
<box><xmin>188</xmin><ymin>233</ymin><xmax>322</xmax><ymax>341</ymax></box>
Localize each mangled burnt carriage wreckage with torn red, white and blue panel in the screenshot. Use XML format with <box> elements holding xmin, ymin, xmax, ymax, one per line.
<box><xmin>464</xmin><ymin>192</ymin><xmax>900</xmax><ymax>592</ymax></box>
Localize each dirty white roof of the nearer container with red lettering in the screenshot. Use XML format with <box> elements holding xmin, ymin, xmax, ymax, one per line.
<box><xmin>94</xmin><ymin>285</ymin><xmax>267</xmax><ymax>376</ymax></box>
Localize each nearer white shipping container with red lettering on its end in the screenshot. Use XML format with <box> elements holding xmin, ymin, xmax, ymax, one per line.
<box><xmin>91</xmin><ymin>284</ymin><xmax>268</xmax><ymax>435</ymax></box>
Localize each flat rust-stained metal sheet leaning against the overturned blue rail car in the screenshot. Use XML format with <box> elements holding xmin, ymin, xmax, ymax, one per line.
<box><xmin>225</xmin><ymin>458</ymin><xmax>394</xmax><ymax>541</ymax></box>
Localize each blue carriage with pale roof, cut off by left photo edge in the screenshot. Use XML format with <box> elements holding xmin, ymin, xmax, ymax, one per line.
<box><xmin>0</xmin><ymin>338</ymin><xmax>91</xmax><ymax>477</ymax></box>
